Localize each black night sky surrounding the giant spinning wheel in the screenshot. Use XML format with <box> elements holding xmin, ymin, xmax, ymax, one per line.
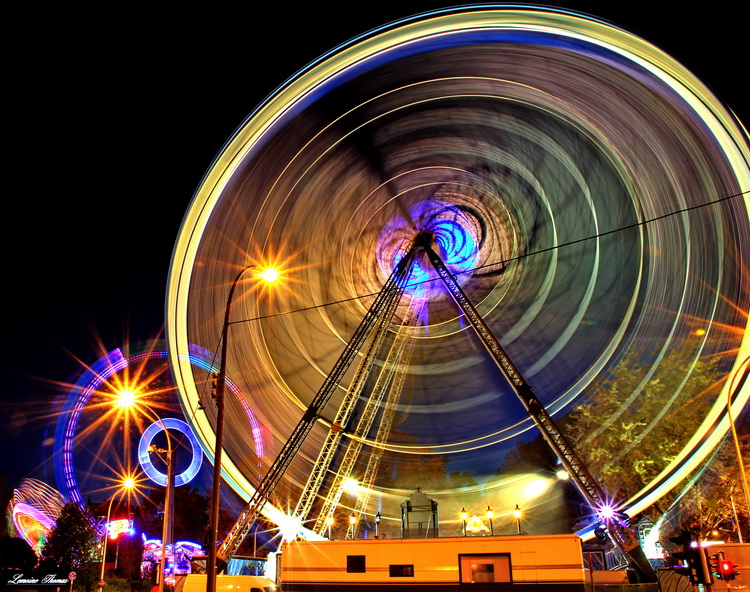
<box><xmin>0</xmin><ymin>3</ymin><xmax>750</xmax><ymax>494</ymax></box>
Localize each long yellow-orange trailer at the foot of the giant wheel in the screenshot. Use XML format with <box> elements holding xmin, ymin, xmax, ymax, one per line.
<box><xmin>277</xmin><ymin>535</ymin><xmax>587</xmax><ymax>592</ymax></box>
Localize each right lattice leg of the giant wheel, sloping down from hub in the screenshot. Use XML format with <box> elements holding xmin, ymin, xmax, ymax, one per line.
<box><xmin>424</xmin><ymin>233</ymin><xmax>656</xmax><ymax>582</ymax></box>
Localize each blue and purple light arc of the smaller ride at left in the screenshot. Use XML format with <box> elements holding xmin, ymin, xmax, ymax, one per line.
<box><xmin>54</xmin><ymin>344</ymin><xmax>265</xmax><ymax>505</ymax></box>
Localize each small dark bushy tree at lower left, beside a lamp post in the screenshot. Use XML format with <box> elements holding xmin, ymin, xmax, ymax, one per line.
<box><xmin>41</xmin><ymin>502</ymin><xmax>100</xmax><ymax>589</ymax></box>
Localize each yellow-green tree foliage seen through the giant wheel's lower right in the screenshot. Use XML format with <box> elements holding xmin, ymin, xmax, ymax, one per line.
<box><xmin>560</xmin><ymin>352</ymin><xmax>720</xmax><ymax>499</ymax></box>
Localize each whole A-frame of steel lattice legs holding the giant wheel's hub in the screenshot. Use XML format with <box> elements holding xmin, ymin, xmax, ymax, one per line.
<box><xmin>217</xmin><ymin>233</ymin><xmax>655</xmax><ymax>581</ymax></box>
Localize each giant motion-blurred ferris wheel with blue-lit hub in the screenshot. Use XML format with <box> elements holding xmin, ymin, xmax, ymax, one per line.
<box><xmin>167</xmin><ymin>8</ymin><xmax>750</xmax><ymax>564</ymax></box>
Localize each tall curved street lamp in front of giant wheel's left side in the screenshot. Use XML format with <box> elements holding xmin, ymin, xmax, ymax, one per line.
<box><xmin>206</xmin><ymin>265</ymin><xmax>279</xmax><ymax>592</ymax></box>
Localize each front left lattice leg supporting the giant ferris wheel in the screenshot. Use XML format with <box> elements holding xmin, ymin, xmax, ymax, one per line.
<box><xmin>216</xmin><ymin>245</ymin><xmax>416</xmax><ymax>571</ymax></box>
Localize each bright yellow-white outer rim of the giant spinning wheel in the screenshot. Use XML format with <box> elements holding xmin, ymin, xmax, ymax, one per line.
<box><xmin>167</xmin><ymin>7</ymin><xmax>750</xmax><ymax>528</ymax></box>
